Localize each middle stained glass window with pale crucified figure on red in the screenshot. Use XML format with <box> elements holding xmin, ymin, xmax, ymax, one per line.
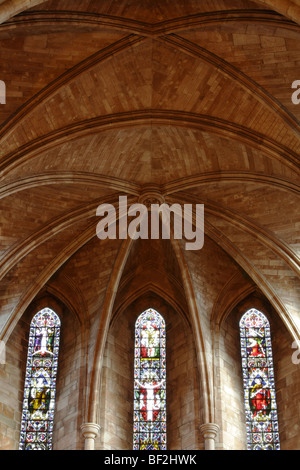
<box><xmin>133</xmin><ymin>309</ymin><xmax>166</xmax><ymax>450</ymax></box>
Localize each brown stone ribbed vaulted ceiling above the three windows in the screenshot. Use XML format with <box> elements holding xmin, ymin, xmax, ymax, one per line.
<box><xmin>0</xmin><ymin>0</ymin><xmax>300</xmax><ymax>348</ymax></box>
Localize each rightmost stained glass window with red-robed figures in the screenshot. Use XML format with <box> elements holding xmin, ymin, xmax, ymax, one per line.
<box><xmin>240</xmin><ymin>308</ymin><xmax>280</xmax><ymax>450</ymax></box>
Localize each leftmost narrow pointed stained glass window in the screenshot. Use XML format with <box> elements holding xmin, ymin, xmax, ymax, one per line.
<box><xmin>19</xmin><ymin>308</ymin><xmax>60</xmax><ymax>450</ymax></box>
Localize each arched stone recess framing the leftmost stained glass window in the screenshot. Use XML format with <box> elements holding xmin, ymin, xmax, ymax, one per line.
<box><xmin>0</xmin><ymin>289</ymin><xmax>84</xmax><ymax>450</ymax></box>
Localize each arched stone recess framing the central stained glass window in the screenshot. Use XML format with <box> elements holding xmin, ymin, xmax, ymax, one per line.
<box><xmin>98</xmin><ymin>288</ymin><xmax>203</xmax><ymax>450</ymax></box>
